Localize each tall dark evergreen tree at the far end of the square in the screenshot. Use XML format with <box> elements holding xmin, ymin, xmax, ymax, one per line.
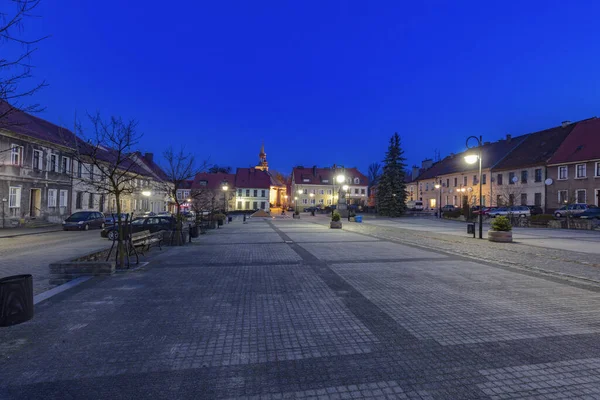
<box><xmin>377</xmin><ymin>132</ymin><xmax>406</xmax><ymax>217</ymax></box>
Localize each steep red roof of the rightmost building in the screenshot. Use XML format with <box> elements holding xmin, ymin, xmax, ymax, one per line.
<box><xmin>548</xmin><ymin>118</ymin><xmax>600</xmax><ymax>164</ymax></box>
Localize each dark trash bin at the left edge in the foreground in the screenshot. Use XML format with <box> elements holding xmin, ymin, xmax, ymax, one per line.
<box><xmin>0</xmin><ymin>274</ymin><xmax>33</xmax><ymax>326</ymax></box>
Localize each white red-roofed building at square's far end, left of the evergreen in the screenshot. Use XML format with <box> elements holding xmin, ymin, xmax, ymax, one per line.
<box><xmin>290</xmin><ymin>164</ymin><xmax>369</xmax><ymax>209</ymax></box>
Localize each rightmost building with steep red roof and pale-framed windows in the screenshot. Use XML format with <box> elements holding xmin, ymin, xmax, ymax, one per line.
<box><xmin>547</xmin><ymin>118</ymin><xmax>600</xmax><ymax>211</ymax></box>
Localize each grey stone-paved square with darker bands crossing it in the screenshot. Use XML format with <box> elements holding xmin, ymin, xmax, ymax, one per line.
<box><xmin>0</xmin><ymin>219</ymin><xmax>600</xmax><ymax>399</ymax></box>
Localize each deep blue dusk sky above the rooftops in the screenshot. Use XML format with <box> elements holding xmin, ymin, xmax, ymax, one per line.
<box><xmin>16</xmin><ymin>0</ymin><xmax>600</xmax><ymax>173</ymax></box>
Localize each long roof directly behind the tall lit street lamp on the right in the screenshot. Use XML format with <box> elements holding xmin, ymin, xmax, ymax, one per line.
<box><xmin>416</xmin><ymin>135</ymin><xmax>528</xmax><ymax>181</ymax></box>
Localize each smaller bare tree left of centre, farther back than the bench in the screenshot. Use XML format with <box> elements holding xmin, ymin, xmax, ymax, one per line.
<box><xmin>163</xmin><ymin>147</ymin><xmax>206</xmax><ymax>245</ymax></box>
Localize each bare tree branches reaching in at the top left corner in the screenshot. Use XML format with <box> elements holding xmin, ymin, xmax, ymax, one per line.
<box><xmin>0</xmin><ymin>0</ymin><xmax>47</xmax><ymax>123</ymax></box>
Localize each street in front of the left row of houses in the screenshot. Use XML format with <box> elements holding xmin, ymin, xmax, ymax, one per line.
<box><xmin>0</xmin><ymin>230</ymin><xmax>110</xmax><ymax>294</ymax></box>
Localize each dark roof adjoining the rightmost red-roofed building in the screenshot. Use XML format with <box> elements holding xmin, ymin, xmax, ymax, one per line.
<box><xmin>494</xmin><ymin>121</ymin><xmax>598</xmax><ymax>170</ymax></box>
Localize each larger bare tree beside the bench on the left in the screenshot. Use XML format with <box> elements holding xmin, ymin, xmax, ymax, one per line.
<box><xmin>70</xmin><ymin>114</ymin><xmax>143</xmax><ymax>268</ymax></box>
